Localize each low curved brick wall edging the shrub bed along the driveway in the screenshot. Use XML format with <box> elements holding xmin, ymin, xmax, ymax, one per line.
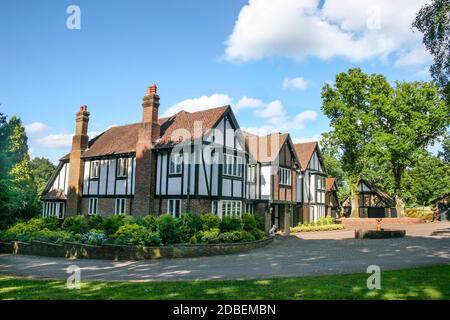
<box><xmin>0</xmin><ymin>238</ymin><xmax>273</xmax><ymax>260</ymax></box>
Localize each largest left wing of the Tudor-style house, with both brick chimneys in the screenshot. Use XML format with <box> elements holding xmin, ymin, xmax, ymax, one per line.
<box><xmin>41</xmin><ymin>85</ymin><xmax>248</xmax><ymax>219</ymax></box>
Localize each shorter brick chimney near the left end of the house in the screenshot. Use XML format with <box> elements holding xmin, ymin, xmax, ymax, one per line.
<box><xmin>66</xmin><ymin>106</ymin><xmax>89</xmax><ymax>216</ymax></box>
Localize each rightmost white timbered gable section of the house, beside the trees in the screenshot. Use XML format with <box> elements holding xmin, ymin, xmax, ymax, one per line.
<box><xmin>294</xmin><ymin>142</ymin><xmax>327</xmax><ymax>223</ymax></box>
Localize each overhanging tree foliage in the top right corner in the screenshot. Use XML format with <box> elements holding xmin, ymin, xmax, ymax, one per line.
<box><xmin>413</xmin><ymin>0</ymin><xmax>450</xmax><ymax>103</ymax></box>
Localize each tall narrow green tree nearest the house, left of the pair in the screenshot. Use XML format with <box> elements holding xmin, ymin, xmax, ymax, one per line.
<box><xmin>322</xmin><ymin>69</ymin><xmax>382</xmax><ymax>217</ymax></box>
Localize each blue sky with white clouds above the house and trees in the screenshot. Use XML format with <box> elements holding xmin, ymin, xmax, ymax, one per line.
<box><xmin>0</xmin><ymin>0</ymin><xmax>432</xmax><ymax>162</ymax></box>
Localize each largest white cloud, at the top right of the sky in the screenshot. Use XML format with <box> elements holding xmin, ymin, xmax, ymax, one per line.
<box><xmin>225</xmin><ymin>0</ymin><xmax>429</xmax><ymax>67</ymax></box>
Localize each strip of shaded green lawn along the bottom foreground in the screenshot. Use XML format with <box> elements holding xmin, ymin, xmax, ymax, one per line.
<box><xmin>0</xmin><ymin>265</ymin><xmax>450</xmax><ymax>300</ymax></box>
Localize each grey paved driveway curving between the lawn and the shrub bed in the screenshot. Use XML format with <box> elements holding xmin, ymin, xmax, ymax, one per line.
<box><xmin>0</xmin><ymin>222</ymin><xmax>450</xmax><ymax>281</ymax></box>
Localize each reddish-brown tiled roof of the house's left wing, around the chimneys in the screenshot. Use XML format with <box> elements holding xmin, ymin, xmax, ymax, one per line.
<box><xmin>61</xmin><ymin>106</ymin><xmax>230</xmax><ymax>161</ymax></box>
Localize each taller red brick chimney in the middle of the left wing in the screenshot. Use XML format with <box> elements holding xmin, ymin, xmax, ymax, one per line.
<box><xmin>133</xmin><ymin>84</ymin><xmax>161</xmax><ymax>216</ymax></box>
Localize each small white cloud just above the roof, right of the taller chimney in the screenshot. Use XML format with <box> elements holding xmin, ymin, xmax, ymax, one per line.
<box><xmin>162</xmin><ymin>93</ymin><xmax>233</xmax><ymax>117</ymax></box>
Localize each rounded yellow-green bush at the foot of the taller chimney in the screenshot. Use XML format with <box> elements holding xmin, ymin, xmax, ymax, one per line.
<box><xmin>113</xmin><ymin>223</ymin><xmax>161</xmax><ymax>246</ymax></box>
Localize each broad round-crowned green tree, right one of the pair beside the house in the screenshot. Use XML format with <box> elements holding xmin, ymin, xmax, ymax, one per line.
<box><xmin>367</xmin><ymin>82</ymin><xmax>450</xmax><ymax>215</ymax></box>
